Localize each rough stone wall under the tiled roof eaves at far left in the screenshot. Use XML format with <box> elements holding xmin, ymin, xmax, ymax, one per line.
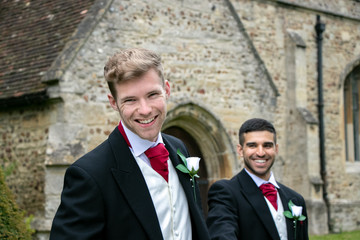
<box><xmin>0</xmin><ymin>105</ymin><xmax>54</xmax><ymax>216</ymax></box>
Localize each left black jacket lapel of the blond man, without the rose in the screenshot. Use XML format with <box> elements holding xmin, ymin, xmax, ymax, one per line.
<box><xmin>109</xmin><ymin>128</ymin><xmax>162</xmax><ymax>240</ymax></box>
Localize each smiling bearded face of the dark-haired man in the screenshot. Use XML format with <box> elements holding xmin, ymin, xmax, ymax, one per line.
<box><xmin>237</xmin><ymin>130</ymin><xmax>278</xmax><ymax>180</ymax></box>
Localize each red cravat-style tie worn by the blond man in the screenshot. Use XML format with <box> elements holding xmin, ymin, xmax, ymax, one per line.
<box><xmin>145</xmin><ymin>143</ymin><xmax>169</xmax><ymax>181</ymax></box>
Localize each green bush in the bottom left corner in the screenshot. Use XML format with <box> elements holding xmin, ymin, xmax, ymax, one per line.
<box><xmin>0</xmin><ymin>167</ymin><xmax>31</xmax><ymax>240</ymax></box>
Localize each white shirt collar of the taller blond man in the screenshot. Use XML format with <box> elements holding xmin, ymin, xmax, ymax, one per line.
<box><xmin>121</xmin><ymin>122</ymin><xmax>165</xmax><ymax>157</ymax></box>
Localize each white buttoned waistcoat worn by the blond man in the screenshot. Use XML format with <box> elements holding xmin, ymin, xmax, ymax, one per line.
<box><xmin>136</xmin><ymin>157</ymin><xmax>192</xmax><ymax>240</ymax></box>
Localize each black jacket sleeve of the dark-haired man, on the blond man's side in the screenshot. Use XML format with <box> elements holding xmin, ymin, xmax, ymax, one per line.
<box><xmin>206</xmin><ymin>180</ymin><xmax>239</xmax><ymax>240</ymax></box>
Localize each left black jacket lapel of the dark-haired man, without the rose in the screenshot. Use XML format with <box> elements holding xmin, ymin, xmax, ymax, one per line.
<box><xmin>238</xmin><ymin>170</ymin><xmax>280</xmax><ymax>240</ymax></box>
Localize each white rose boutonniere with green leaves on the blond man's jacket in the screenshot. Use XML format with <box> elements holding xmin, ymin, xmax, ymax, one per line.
<box><xmin>176</xmin><ymin>149</ymin><xmax>200</xmax><ymax>202</ymax></box>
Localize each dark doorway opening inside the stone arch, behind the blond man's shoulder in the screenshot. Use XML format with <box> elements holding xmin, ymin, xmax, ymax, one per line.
<box><xmin>163</xmin><ymin>127</ymin><xmax>209</xmax><ymax>217</ymax></box>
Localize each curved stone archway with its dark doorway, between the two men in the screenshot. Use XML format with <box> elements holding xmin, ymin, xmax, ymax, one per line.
<box><xmin>162</xmin><ymin>103</ymin><xmax>237</xmax><ymax>215</ymax></box>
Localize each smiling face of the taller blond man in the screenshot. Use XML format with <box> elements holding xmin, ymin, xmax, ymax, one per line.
<box><xmin>108</xmin><ymin>69</ymin><xmax>170</xmax><ymax>142</ymax></box>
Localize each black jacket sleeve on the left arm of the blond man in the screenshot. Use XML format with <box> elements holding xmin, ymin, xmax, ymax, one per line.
<box><xmin>50</xmin><ymin>165</ymin><xmax>105</xmax><ymax>240</ymax></box>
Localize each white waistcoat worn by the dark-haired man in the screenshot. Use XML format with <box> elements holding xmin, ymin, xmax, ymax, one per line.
<box><xmin>264</xmin><ymin>193</ymin><xmax>287</xmax><ymax>240</ymax></box>
